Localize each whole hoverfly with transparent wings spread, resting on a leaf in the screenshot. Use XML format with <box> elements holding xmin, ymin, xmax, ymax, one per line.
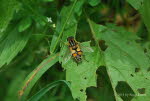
<box><xmin>59</xmin><ymin>36</ymin><xmax>93</xmax><ymax>65</ymax></box>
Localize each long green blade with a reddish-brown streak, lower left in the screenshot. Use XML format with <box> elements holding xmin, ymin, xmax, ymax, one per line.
<box><xmin>19</xmin><ymin>53</ymin><xmax>59</xmax><ymax>101</ymax></box>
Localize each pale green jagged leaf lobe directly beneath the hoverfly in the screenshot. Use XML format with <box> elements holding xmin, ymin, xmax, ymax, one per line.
<box><xmin>60</xmin><ymin>42</ymin><xmax>101</xmax><ymax>101</ymax></box>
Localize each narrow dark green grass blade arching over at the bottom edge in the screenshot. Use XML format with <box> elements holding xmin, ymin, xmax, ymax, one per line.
<box><xmin>27</xmin><ymin>80</ymin><xmax>70</xmax><ymax>101</ymax></box>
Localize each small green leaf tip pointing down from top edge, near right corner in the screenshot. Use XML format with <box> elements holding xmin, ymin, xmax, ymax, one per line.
<box><xmin>127</xmin><ymin>0</ymin><xmax>144</xmax><ymax>10</ymax></box>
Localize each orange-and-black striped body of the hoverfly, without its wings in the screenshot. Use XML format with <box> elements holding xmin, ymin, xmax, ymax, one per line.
<box><xmin>67</xmin><ymin>36</ymin><xmax>83</xmax><ymax>63</ymax></box>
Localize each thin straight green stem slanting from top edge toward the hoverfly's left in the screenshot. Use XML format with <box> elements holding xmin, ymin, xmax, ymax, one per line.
<box><xmin>51</xmin><ymin>0</ymin><xmax>77</xmax><ymax>53</ymax></box>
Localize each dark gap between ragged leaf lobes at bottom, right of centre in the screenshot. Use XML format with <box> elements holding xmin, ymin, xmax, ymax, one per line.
<box><xmin>86</xmin><ymin>66</ymin><xmax>115</xmax><ymax>101</ymax></box>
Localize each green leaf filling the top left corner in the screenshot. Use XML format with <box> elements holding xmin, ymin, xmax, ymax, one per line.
<box><xmin>0</xmin><ymin>0</ymin><xmax>19</xmax><ymax>36</ymax></box>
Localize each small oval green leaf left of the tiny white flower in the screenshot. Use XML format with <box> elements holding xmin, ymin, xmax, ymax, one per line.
<box><xmin>18</xmin><ymin>17</ymin><xmax>32</xmax><ymax>32</ymax></box>
